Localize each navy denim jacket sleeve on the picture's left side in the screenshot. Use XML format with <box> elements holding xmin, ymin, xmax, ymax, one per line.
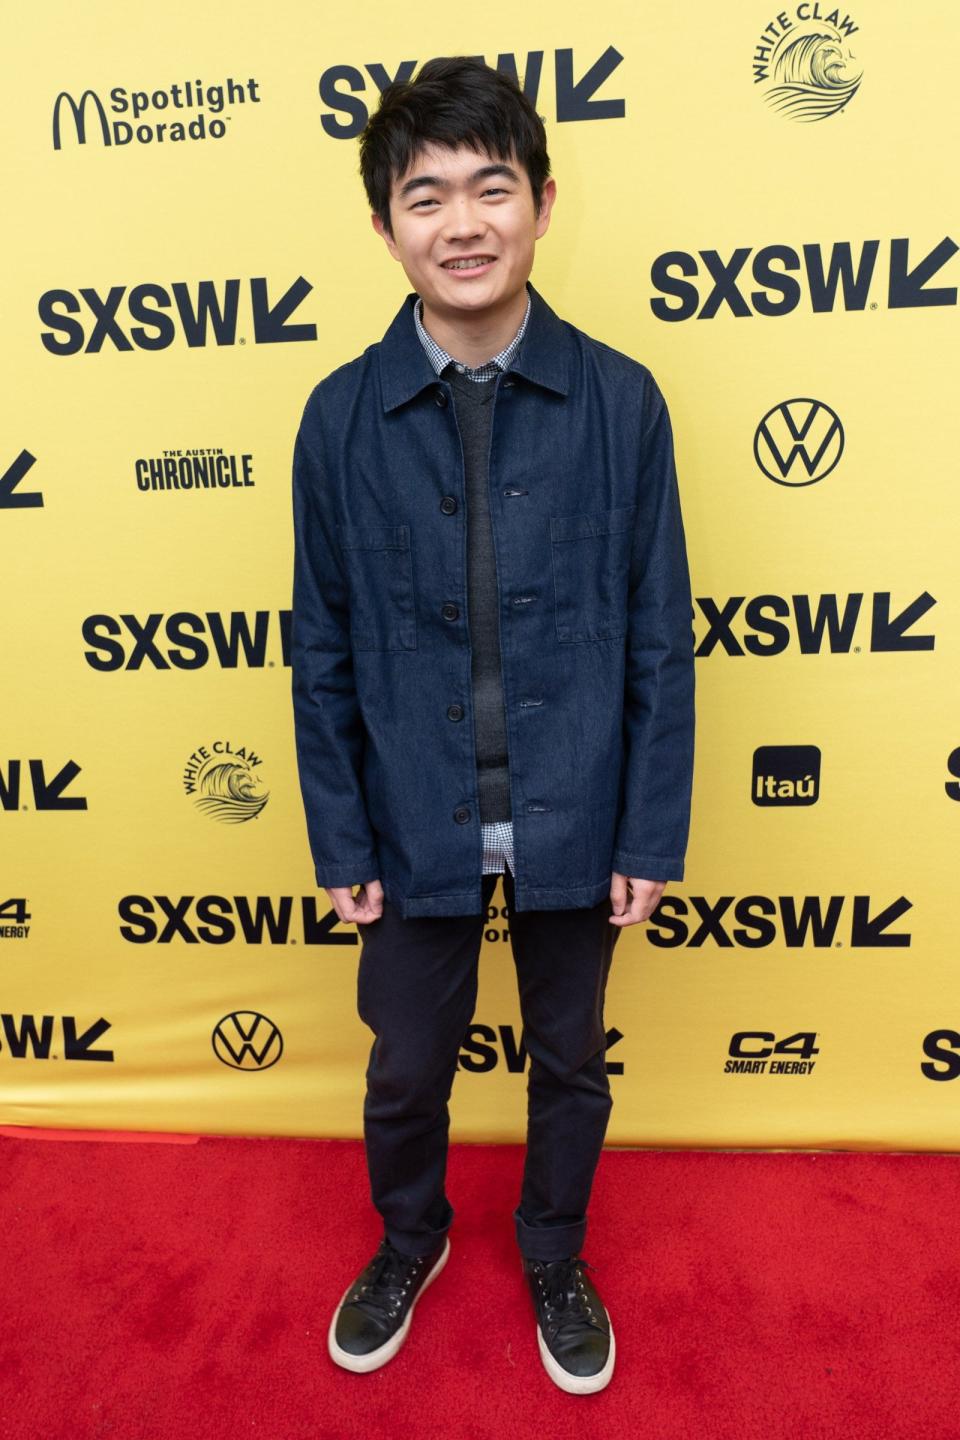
<box><xmin>291</xmin><ymin>402</ymin><xmax>380</xmax><ymax>886</ymax></box>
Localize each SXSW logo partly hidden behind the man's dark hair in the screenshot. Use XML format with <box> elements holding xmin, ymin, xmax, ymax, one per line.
<box><xmin>320</xmin><ymin>45</ymin><xmax>626</xmax><ymax>140</ymax></box>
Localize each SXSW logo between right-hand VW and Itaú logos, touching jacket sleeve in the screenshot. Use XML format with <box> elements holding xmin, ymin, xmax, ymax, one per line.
<box><xmin>697</xmin><ymin>590</ymin><xmax>937</xmax><ymax>658</ymax></box>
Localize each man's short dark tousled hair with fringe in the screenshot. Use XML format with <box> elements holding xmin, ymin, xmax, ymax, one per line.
<box><xmin>360</xmin><ymin>55</ymin><xmax>550</xmax><ymax>235</ymax></box>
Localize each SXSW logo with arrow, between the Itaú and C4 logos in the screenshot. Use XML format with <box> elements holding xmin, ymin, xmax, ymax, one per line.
<box><xmin>645</xmin><ymin>896</ymin><xmax>913</xmax><ymax>950</ymax></box>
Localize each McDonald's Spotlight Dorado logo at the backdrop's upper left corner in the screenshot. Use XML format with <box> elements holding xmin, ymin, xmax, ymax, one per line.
<box><xmin>53</xmin><ymin>76</ymin><xmax>261</xmax><ymax>150</ymax></box>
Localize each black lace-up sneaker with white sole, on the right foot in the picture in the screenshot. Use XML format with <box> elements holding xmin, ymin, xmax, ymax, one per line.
<box><xmin>522</xmin><ymin>1256</ymin><xmax>616</xmax><ymax>1395</ymax></box>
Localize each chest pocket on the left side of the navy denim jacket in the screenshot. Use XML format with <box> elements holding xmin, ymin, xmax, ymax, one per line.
<box><xmin>337</xmin><ymin>524</ymin><xmax>417</xmax><ymax>649</ymax></box>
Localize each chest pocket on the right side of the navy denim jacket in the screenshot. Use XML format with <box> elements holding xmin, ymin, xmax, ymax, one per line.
<box><xmin>550</xmin><ymin>505</ymin><xmax>636</xmax><ymax>644</ymax></box>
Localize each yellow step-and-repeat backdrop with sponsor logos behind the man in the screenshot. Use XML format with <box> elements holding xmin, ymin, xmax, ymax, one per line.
<box><xmin>0</xmin><ymin>0</ymin><xmax>960</xmax><ymax>1149</ymax></box>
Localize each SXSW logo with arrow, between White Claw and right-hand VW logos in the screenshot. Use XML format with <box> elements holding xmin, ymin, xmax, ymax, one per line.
<box><xmin>651</xmin><ymin>235</ymin><xmax>960</xmax><ymax>321</ymax></box>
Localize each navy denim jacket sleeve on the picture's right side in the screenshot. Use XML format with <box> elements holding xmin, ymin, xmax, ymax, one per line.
<box><xmin>613</xmin><ymin>376</ymin><xmax>694</xmax><ymax>880</ymax></box>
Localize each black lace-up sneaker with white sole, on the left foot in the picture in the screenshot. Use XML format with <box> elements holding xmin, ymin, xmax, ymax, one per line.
<box><xmin>327</xmin><ymin>1236</ymin><xmax>450</xmax><ymax>1374</ymax></box>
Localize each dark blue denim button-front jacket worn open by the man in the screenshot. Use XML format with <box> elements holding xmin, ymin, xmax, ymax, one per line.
<box><xmin>292</xmin><ymin>285</ymin><xmax>694</xmax><ymax>917</ymax></box>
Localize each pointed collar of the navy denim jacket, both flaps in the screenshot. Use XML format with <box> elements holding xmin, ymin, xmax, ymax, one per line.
<box><xmin>379</xmin><ymin>281</ymin><xmax>573</xmax><ymax>410</ymax></box>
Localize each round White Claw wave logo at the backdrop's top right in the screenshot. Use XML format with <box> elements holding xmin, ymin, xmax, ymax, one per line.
<box><xmin>753</xmin><ymin>0</ymin><xmax>864</xmax><ymax>124</ymax></box>
